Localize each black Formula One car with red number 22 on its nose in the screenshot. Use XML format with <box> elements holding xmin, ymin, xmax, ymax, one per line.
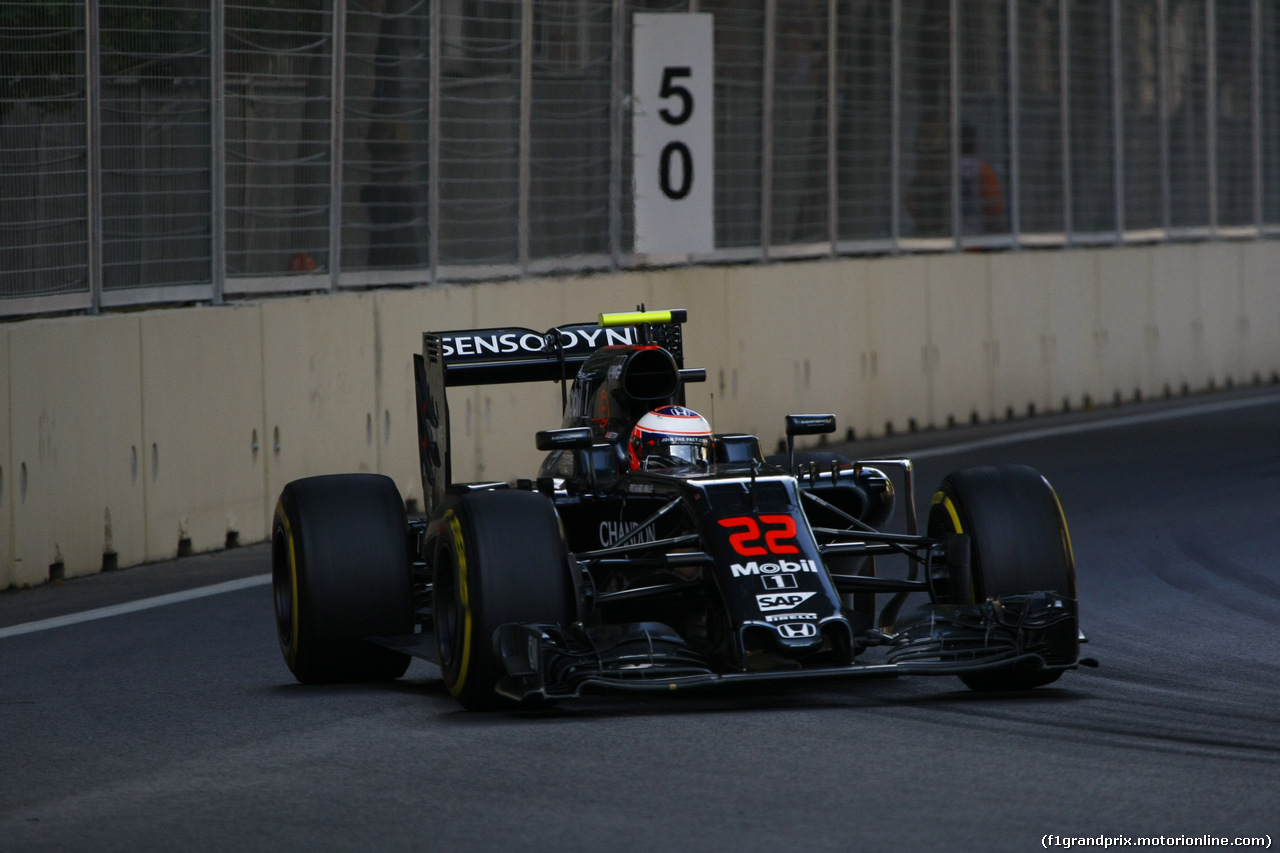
<box><xmin>271</xmin><ymin>310</ymin><xmax>1092</xmax><ymax>710</ymax></box>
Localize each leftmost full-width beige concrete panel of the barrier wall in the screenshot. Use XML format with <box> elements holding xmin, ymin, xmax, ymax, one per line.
<box><xmin>9</xmin><ymin>315</ymin><xmax>145</xmax><ymax>585</ymax></box>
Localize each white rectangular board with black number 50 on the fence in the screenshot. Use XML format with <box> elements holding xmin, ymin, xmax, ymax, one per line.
<box><xmin>631</xmin><ymin>13</ymin><xmax>716</xmax><ymax>255</ymax></box>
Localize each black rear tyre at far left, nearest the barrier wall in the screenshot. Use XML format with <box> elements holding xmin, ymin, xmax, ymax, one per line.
<box><xmin>271</xmin><ymin>474</ymin><xmax>413</xmax><ymax>684</ymax></box>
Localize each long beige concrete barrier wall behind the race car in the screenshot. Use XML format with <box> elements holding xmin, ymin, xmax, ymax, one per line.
<box><xmin>0</xmin><ymin>241</ymin><xmax>1280</xmax><ymax>587</ymax></box>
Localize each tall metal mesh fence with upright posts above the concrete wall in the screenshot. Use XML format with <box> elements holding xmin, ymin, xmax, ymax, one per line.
<box><xmin>0</xmin><ymin>0</ymin><xmax>1280</xmax><ymax>316</ymax></box>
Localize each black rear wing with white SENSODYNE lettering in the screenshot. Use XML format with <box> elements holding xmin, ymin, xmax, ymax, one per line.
<box><xmin>413</xmin><ymin>310</ymin><xmax>686</xmax><ymax>514</ymax></box>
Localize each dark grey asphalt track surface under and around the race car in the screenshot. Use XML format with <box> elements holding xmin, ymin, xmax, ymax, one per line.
<box><xmin>0</xmin><ymin>388</ymin><xmax>1280</xmax><ymax>852</ymax></box>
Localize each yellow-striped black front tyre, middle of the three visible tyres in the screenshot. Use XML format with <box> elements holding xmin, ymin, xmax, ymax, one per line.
<box><xmin>433</xmin><ymin>491</ymin><xmax>575</xmax><ymax>711</ymax></box>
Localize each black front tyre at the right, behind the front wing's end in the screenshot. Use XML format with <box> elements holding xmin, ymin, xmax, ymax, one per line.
<box><xmin>928</xmin><ymin>465</ymin><xmax>1076</xmax><ymax>690</ymax></box>
